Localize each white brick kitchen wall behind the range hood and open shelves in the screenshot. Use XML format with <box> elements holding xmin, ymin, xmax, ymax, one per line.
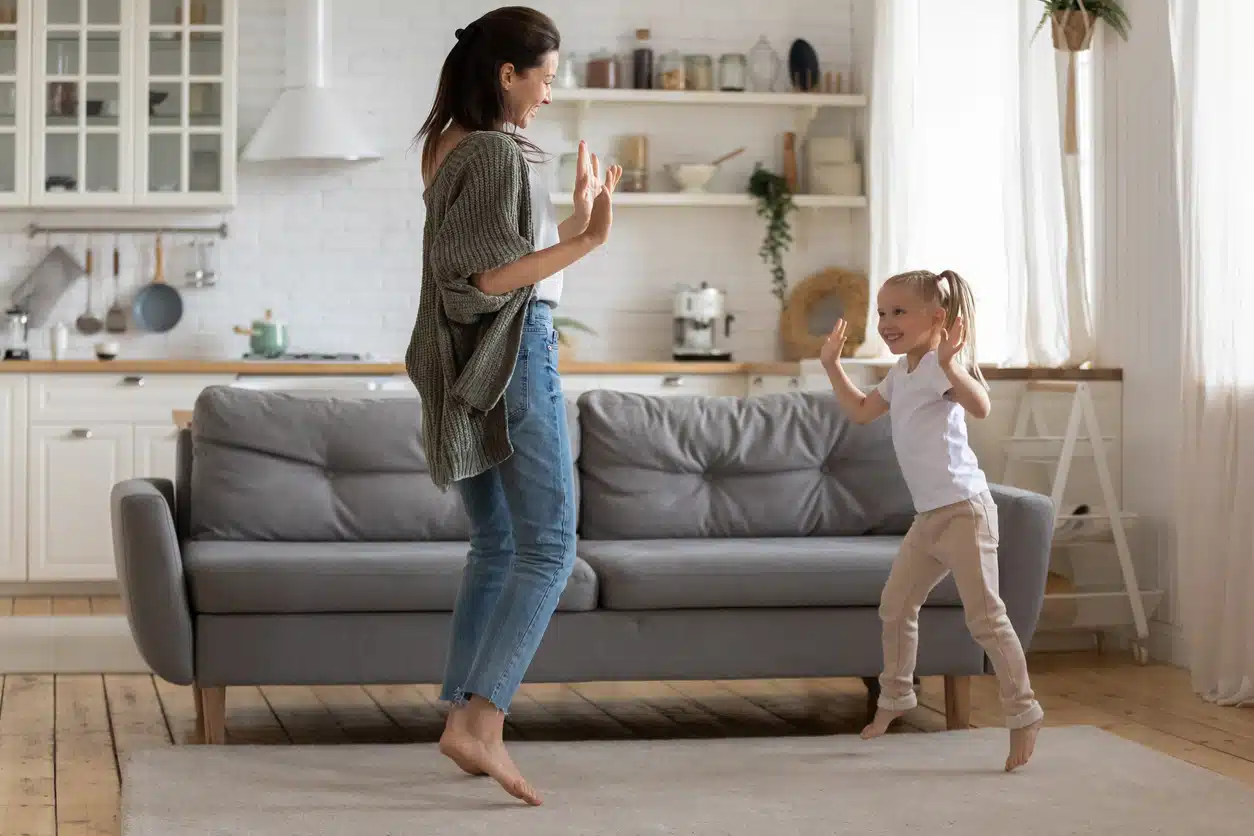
<box><xmin>0</xmin><ymin>0</ymin><xmax>872</xmax><ymax>360</ymax></box>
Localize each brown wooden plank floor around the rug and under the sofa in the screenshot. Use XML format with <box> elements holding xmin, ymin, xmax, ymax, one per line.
<box><xmin>0</xmin><ymin>619</ymin><xmax>1254</xmax><ymax>836</ymax></box>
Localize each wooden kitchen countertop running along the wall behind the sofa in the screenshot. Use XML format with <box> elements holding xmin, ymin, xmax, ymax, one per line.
<box><xmin>0</xmin><ymin>358</ymin><xmax>1124</xmax><ymax>380</ymax></box>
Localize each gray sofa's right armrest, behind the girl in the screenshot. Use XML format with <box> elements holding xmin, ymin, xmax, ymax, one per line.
<box><xmin>988</xmin><ymin>485</ymin><xmax>1053</xmax><ymax>661</ymax></box>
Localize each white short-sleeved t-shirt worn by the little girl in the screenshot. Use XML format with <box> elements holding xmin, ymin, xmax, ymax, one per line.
<box><xmin>877</xmin><ymin>351</ymin><xmax>988</xmax><ymax>514</ymax></box>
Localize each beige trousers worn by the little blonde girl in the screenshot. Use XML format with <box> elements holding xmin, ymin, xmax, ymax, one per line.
<box><xmin>879</xmin><ymin>491</ymin><xmax>1043</xmax><ymax>728</ymax></box>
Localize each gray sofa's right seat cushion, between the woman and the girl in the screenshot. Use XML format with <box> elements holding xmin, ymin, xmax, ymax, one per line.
<box><xmin>578</xmin><ymin>536</ymin><xmax>962</xmax><ymax>609</ymax></box>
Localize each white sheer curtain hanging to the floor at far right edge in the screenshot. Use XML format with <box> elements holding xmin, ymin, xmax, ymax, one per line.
<box><xmin>1170</xmin><ymin>0</ymin><xmax>1254</xmax><ymax>704</ymax></box>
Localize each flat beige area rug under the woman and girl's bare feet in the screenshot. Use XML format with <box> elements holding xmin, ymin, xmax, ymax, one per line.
<box><xmin>122</xmin><ymin>727</ymin><xmax>1254</xmax><ymax>836</ymax></box>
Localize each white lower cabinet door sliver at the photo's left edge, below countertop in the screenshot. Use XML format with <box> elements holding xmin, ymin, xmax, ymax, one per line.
<box><xmin>0</xmin><ymin>375</ymin><xmax>26</xmax><ymax>580</ymax></box>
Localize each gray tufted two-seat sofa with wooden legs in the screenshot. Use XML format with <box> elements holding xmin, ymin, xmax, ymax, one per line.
<box><xmin>112</xmin><ymin>387</ymin><xmax>1052</xmax><ymax>742</ymax></box>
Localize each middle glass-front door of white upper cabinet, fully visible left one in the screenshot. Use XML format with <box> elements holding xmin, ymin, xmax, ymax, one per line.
<box><xmin>31</xmin><ymin>0</ymin><xmax>134</xmax><ymax>206</ymax></box>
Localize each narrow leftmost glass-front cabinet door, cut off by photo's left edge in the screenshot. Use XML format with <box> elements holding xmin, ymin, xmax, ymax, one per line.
<box><xmin>0</xmin><ymin>0</ymin><xmax>30</xmax><ymax>206</ymax></box>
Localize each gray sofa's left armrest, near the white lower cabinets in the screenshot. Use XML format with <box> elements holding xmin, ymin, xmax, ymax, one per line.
<box><xmin>109</xmin><ymin>479</ymin><xmax>194</xmax><ymax>686</ymax></box>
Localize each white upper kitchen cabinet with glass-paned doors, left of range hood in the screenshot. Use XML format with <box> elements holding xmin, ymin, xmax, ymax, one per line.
<box><xmin>0</xmin><ymin>0</ymin><xmax>238</xmax><ymax>209</ymax></box>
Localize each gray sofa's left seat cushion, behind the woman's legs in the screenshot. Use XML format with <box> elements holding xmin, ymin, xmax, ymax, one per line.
<box><xmin>183</xmin><ymin>540</ymin><xmax>597</xmax><ymax>614</ymax></box>
